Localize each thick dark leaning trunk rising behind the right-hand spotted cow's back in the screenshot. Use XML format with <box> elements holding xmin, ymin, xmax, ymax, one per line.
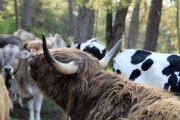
<box><xmin>143</xmin><ymin>0</ymin><xmax>162</xmax><ymax>51</ymax></box>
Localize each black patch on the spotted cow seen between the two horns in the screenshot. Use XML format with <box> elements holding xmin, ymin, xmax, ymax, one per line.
<box><xmin>83</xmin><ymin>46</ymin><xmax>106</xmax><ymax>60</ymax></box>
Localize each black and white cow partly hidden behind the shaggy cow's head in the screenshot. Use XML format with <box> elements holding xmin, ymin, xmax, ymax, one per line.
<box><xmin>71</xmin><ymin>38</ymin><xmax>106</xmax><ymax>60</ymax></box>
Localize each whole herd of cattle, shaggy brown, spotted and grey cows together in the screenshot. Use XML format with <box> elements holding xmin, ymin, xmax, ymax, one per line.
<box><xmin>0</xmin><ymin>29</ymin><xmax>180</xmax><ymax>120</ymax></box>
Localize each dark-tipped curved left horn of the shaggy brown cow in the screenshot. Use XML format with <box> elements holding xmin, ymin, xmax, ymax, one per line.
<box><xmin>42</xmin><ymin>34</ymin><xmax>78</xmax><ymax>75</ymax></box>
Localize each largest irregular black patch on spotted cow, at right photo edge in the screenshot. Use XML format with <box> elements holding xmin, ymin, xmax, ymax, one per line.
<box><xmin>162</xmin><ymin>55</ymin><xmax>180</xmax><ymax>92</ymax></box>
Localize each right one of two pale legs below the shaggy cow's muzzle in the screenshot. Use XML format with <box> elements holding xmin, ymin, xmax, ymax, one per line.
<box><xmin>33</xmin><ymin>93</ymin><xmax>43</xmax><ymax>120</ymax></box>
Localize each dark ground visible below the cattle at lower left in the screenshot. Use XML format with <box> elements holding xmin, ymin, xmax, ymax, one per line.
<box><xmin>10</xmin><ymin>99</ymin><xmax>65</xmax><ymax>120</ymax></box>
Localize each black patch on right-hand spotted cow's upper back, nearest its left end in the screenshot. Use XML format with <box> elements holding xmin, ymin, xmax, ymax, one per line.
<box><xmin>131</xmin><ymin>50</ymin><xmax>152</xmax><ymax>65</ymax></box>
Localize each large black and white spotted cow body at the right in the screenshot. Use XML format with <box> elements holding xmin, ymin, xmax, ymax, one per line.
<box><xmin>113</xmin><ymin>49</ymin><xmax>180</xmax><ymax>92</ymax></box>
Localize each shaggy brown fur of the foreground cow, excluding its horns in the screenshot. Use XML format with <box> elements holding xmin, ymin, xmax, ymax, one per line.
<box><xmin>29</xmin><ymin>48</ymin><xmax>180</xmax><ymax>120</ymax></box>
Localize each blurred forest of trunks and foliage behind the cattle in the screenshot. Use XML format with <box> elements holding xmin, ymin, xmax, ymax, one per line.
<box><xmin>0</xmin><ymin>0</ymin><xmax>180</xmax><ymax>53</ymax></box>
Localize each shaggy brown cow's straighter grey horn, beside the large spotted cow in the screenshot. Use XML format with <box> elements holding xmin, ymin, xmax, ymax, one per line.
<box><xmin>99</xmin><ymin>39</ymin><xmax>122</xmax><ymax>69</ymax></box>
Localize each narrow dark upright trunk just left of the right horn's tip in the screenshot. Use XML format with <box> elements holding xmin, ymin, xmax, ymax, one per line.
<box><xmin>106</xmin><ymin>10</ymin><xmax>113</xmax><ymax>51</ymax></box>
